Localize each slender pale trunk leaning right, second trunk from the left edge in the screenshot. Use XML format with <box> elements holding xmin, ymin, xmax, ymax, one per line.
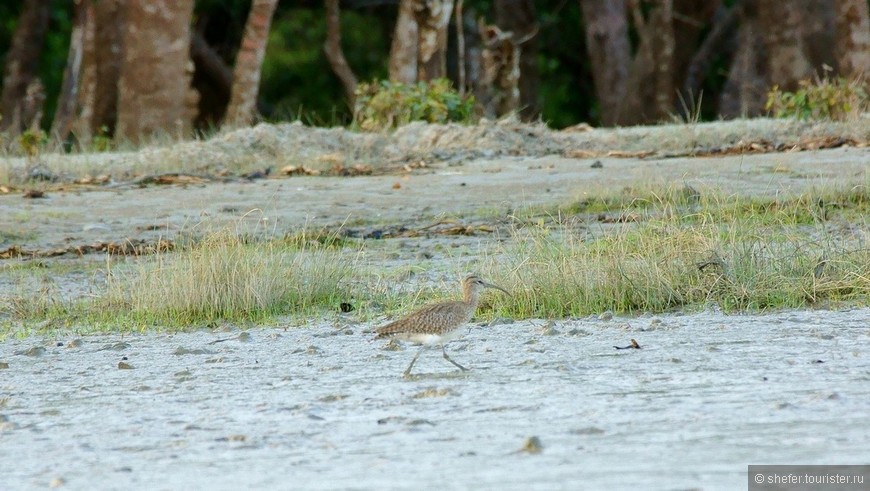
<box><xmin>50</xmin><ymin>0</ymin><xmax>92</xmax><ymax>142</ymax></box>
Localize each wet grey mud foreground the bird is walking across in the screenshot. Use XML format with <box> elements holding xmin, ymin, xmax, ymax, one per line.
<box><xmin>0</xmin><ymin>309</ymin><xmax>870</xmax><ymax>490</ymax></box>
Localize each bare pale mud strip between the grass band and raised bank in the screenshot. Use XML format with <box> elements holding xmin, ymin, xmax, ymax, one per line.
<box><xmin>0</xmin><ymin>148</ymin><xmax>870</xmax><ymax>257</ymax></box>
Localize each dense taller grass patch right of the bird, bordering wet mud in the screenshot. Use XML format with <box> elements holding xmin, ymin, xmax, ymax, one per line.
<box><xmin>488</xmin><ymin>223</ymin><xmax>870</xmax><ymax>318</ymax></box>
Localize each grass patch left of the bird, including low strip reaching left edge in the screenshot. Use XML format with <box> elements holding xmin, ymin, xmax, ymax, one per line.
<box><xmin>0</xmin><ymin>230</ymin><xmax>355</xmax><ymax>330</ymax></box>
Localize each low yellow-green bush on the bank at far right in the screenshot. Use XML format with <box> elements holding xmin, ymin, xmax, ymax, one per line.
<box><xmin>764</xmin><ymin>77</ymin><xmax>870</xmax><ymax>121</ymax></box>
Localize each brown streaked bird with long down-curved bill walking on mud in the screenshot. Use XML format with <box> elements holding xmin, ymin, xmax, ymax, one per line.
<box><xmin>376</xmin><ymin>274</ymin><xmax>510</xmax><ymax>377</ymax></box>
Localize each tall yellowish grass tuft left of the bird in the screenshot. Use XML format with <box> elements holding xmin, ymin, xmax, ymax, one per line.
<box><xmin>102</xmin><ymin>231</ymin><xmax>352</xmax><ymax>326</ymax></box>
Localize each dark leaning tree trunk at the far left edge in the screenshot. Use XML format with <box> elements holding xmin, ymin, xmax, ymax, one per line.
<box><xmin>0</xmin><ymin>0</ymin><xmax>50</xmax><ymax>135</ymax></box>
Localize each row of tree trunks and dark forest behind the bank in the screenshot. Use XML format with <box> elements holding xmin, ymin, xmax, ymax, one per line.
<box><xmin>0</xmin><ymin>0</ymin><xmax>870</xmax><ymax>148</ymax></box>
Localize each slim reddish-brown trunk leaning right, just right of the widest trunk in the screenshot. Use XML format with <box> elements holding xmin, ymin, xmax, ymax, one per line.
<box><xmin>226</xmin><ymin>0</ymin><xmax>278</xmax><ymax>126</ymax></box>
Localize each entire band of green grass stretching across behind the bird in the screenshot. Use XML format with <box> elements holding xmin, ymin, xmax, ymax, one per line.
<box><xmin>0</xmin><ymin>179</ymin><xmax>870</xmax><ymax>335</ymax></box>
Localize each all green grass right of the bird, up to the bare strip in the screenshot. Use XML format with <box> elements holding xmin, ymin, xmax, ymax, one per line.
<box><xmin>487</xmin><ymin>184</ymin><xmax>870</xmax><ymax>318</ymax></box>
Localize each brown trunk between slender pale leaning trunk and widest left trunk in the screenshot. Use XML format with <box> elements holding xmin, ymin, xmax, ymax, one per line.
<box><xmin>73</xmin><ymin>0</ymin><xmax>124</xmax><ymax>143</ymax></box>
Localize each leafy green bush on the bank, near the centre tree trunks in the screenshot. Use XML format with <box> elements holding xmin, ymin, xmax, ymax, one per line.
<box><xmin>353</xmin><ymin>78</ymin><xmax>474</xmax><ymax>131</ymax></box>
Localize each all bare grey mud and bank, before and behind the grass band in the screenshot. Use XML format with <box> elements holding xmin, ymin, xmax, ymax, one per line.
<box><xmin>0</xmin><ymin>122</ymin><xmax>870</xmax><ymax>490</ymax></box>
